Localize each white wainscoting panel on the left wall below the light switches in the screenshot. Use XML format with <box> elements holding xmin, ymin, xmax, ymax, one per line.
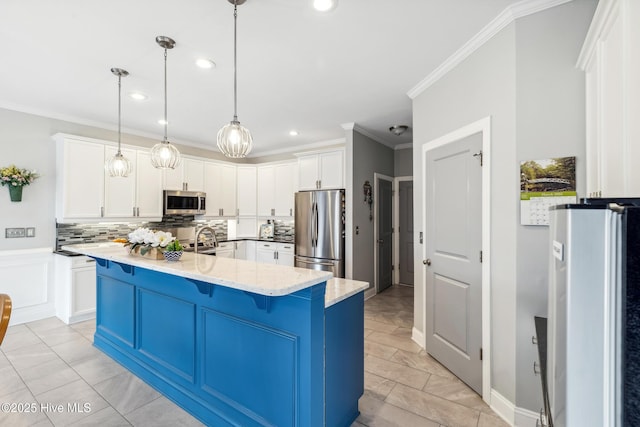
<box><xmin>0</xmin><ymin>248</ymin><xmax>56</xmax><ymax>325</ymax></box>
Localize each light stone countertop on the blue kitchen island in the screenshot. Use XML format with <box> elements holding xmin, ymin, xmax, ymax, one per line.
<box><xmin>62</xmin><ymin>243</ymin><xmax>350</xmax><ymax>300</ymax></box>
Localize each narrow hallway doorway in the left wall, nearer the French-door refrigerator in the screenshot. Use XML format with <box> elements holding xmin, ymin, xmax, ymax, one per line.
<box><xmin>373</xmin><ymin>173</ymin><xmax>393</xmax><ymax>293</ymax></box>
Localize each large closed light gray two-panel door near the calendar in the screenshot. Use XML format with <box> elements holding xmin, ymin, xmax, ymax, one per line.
<box><xmin>424</xmin><ymin>132</ymin><xmax>482</xmax><ymax>394</ymax></box>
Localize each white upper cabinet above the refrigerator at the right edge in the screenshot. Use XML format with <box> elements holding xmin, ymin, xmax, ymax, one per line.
<box><xmin>578</xmin><ymin>0</ymin><xmax>640</xmax><ymax>197</ymax></box>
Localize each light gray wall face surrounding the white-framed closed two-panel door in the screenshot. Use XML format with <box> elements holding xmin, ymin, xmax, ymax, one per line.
<box><xmin>413</xmin><ymin>24</ymin><xmax>518</xmax><ymax>402</ymax></box>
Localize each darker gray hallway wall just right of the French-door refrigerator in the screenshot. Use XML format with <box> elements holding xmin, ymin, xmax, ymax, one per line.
<box><xmin>346</xmin><ymin>131</ymin><xmax>394</xmax><ymax>287</ymax></box>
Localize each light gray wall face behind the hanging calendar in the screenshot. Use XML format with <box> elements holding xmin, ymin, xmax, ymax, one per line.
<box><xmin>516</xmin><ymin>0</ymin><xmax>596</xmax><ymax>411</ymax></box>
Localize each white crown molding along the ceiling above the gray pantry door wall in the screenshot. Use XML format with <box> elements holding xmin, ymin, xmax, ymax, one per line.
<box><xmin>407</xmin><ymin>0</ymin><xmax>572</xmax><ymax>99</ymax></box>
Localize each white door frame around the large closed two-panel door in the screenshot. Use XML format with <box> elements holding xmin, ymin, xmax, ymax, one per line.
<box><xmin>422</xmin><ymin>116</ymin><xmax>491</xmax><ymax>404</ymax></box>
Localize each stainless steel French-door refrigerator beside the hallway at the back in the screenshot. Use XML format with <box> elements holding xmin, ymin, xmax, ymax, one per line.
<box><xmin>295</xmin><ymin>190</ymin><xmax>345</xmax><ymax>277</ymax></box>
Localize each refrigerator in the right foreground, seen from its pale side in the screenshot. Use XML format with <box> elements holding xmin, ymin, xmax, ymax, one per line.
<box><xmin>546</xmin><ymin>199</ymin><xmax>640</xmax><ymax>427</ymax></box>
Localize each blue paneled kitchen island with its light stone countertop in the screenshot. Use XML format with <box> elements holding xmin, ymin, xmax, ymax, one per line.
<box><xmin>65</xmin><ymin>246</ymin><xmax>367</xmax><ymax>427</ymax></box>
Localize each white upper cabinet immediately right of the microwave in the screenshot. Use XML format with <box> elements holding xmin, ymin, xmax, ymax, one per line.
<box><xmin>204</xmin><ymin>162</ymin><xmax>236</xmax><ymax>216</ymax></box>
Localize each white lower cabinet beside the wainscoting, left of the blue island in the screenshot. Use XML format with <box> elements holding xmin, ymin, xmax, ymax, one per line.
<box><xmin>55</xmin><ymin>255</ymin><xmax>96</xmax><ymax>324</ymax></box>
